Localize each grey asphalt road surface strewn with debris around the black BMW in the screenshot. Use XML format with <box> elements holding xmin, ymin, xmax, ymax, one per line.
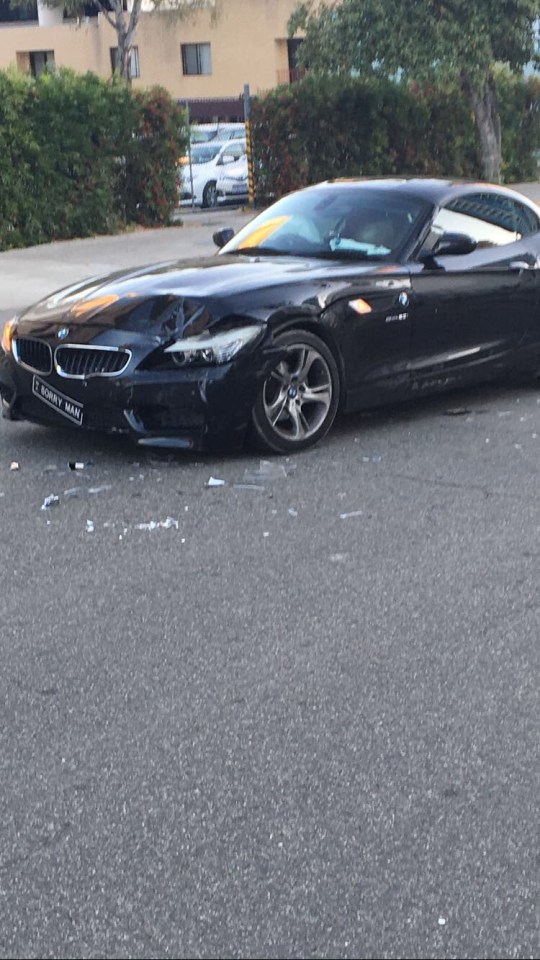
<box><xmin>0</xmin><ymin>193</ymin><xmax>540</xmax><ymax>958</ymax></box>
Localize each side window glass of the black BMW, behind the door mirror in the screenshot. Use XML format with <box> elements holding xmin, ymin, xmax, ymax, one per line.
<box><xmin>426</xmin><ymin>193</ymin><xmax>539</xmax><ymax>248</ymax></box>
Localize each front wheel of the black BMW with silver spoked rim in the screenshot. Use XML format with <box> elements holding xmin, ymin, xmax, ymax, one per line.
<box><xmin>252</xmin><ymin>330</ymin><xmax>340</xmax><ymax>453</ymax></box>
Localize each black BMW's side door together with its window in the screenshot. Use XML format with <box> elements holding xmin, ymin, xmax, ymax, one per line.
<box><xmin>411</xmin><ymin>193</ymin><xmax>539</xmax><ymax>389</ymax></box>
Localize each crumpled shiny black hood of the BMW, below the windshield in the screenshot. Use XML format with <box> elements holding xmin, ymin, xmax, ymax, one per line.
<box><xmin>13</xmin><ymin>254</ymin><xmax>408</xmax><ymax>340</ymax></box>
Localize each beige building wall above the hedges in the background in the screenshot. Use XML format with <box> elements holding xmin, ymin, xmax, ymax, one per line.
<box><xmin>0</xmin><ymin>0</ymin><xmax>297</xmax><ymax>99</ymax></box>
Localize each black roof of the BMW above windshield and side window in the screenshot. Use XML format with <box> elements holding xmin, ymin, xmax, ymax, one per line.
<box><xmin>314</xmin><ymin>177</ymin><xmax>539</xmax><ymax>215</ymax></box>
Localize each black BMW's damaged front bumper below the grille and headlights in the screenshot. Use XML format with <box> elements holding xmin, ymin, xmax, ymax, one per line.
<box><xmin>0</xmin><ymin>351</ymin><xmax>274</xmax><ymax>450</ymax></box>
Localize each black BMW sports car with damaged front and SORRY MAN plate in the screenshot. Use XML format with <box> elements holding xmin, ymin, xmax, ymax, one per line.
<box><xmin>0</xmin><ymin>179</ymin><xmax>540</xmax><ymax>453</ymax></box>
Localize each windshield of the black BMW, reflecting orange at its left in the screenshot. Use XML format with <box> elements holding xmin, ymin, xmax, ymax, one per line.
<box><xmin>223</xmin><ymin>184</ymin><xmax>428</xmax><ymax>260</ymax></box>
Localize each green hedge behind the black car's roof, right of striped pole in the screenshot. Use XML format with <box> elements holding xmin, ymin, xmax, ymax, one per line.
<box><xmin>252</xmin><ymin>72</ymin><xmax>540</xmax><ymax>202</ymax></box>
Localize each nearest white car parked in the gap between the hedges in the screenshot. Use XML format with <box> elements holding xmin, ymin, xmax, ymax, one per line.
<box><xmin>179</xmin><ymin>140</ymin><xmax>246</xmax><ymax>207</ymax></box>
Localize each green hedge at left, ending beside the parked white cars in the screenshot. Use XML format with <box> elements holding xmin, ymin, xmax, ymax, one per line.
<box><xmin>0</xmin><ymin>70</ymin><xmax>186</xmax><ymax>250</ymax></box>
